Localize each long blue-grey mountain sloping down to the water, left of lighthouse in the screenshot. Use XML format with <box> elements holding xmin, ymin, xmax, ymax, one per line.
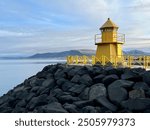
<box><xmin>28</xmin><ymin>50</ymin><xmax>83</xmax><ymax>58</ymax></box>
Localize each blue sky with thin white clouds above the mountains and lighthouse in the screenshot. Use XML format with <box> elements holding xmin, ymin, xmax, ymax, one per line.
<box><xmin>0</xmin><ymin>0</ymin><xmax>150</xmax><ymax>56</ymax></box>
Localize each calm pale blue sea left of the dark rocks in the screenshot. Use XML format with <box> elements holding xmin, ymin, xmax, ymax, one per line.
<box><xmin>0</xmin><ymin>59</ymin><xmax>65</xmax><ymax>96</ymax></box>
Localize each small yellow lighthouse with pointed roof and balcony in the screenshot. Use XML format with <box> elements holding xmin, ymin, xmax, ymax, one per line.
<box><xmin>95</xmin><ymin>18</ymin><xmax>125</xmax><ymax>62</ymax></box>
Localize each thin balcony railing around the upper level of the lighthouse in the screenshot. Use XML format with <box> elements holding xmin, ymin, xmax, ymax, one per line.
<box><xmin>95</xmin><ymin>33</ymin><xmax>125</xmax><ymax>44</ymax></box>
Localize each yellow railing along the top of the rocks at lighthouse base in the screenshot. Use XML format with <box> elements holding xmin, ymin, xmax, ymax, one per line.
<box><xmin>67</xmin><ymin>55</ymin><xmax>150</xmax><ymax>69</ymax></box>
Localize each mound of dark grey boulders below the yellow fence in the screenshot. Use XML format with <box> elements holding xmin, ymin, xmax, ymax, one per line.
<box><xmin>0</xmin><ymin>64</ymin><xmax>150</xmax><ymax>113</ymax></box>
